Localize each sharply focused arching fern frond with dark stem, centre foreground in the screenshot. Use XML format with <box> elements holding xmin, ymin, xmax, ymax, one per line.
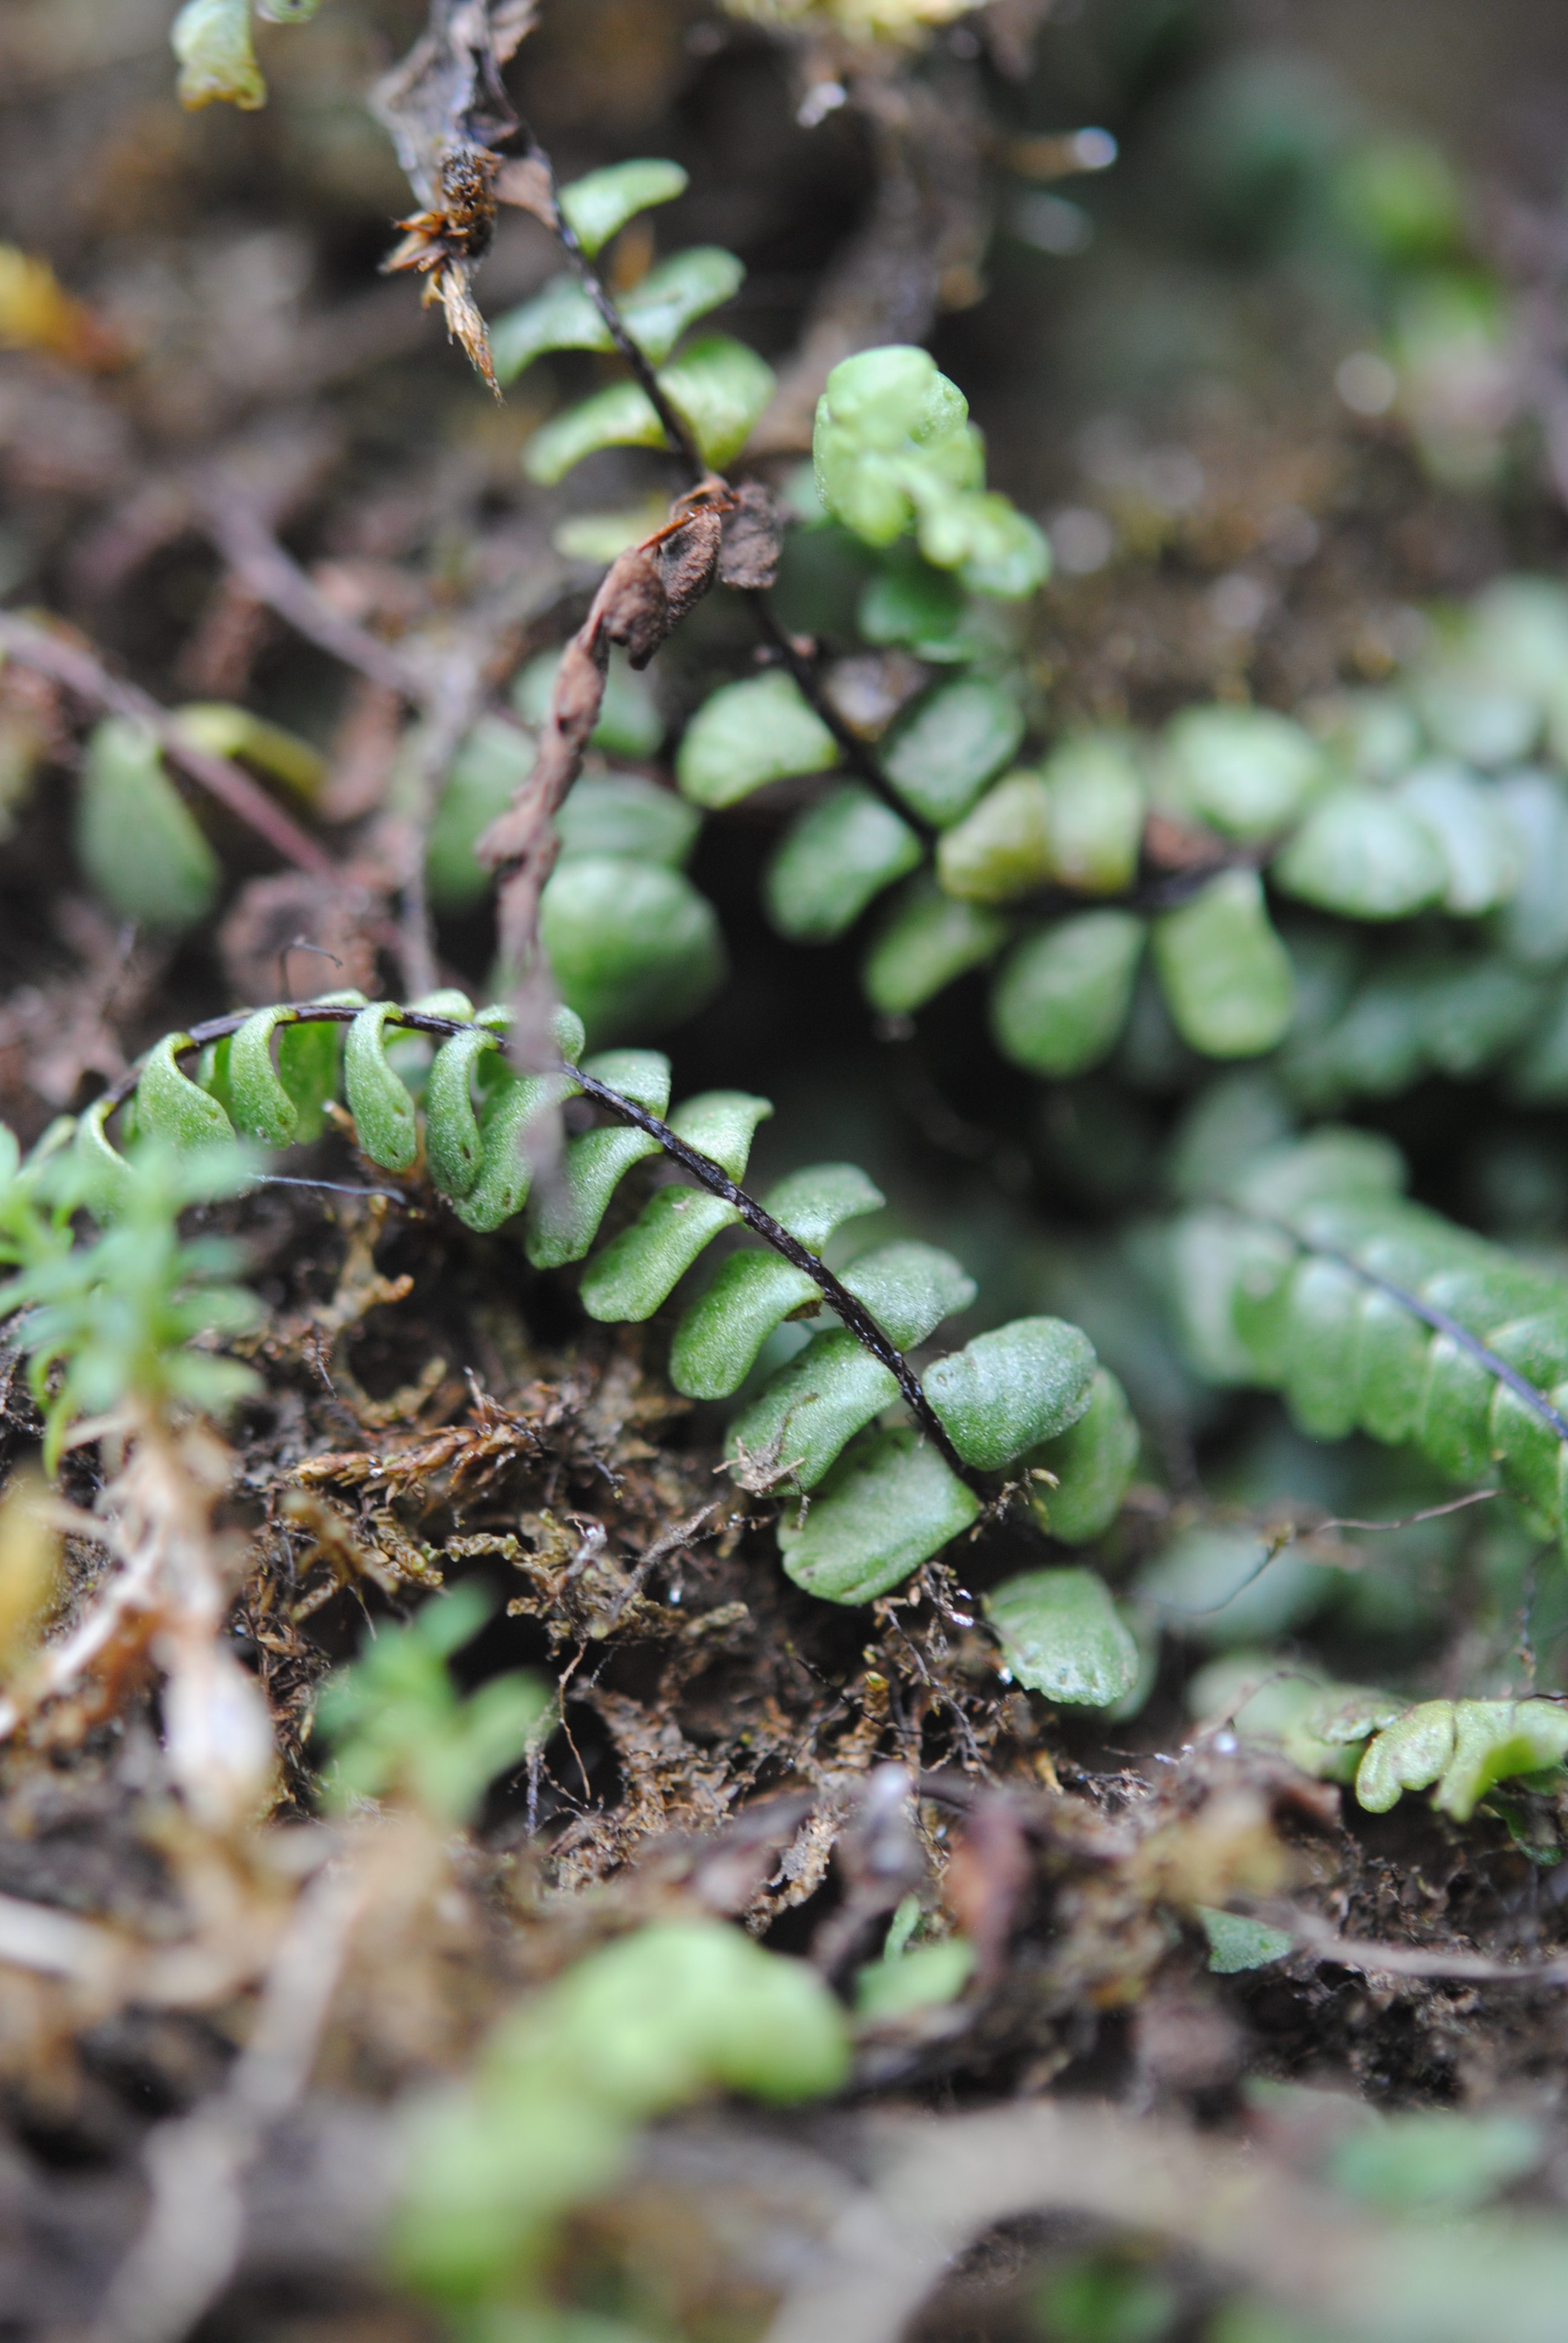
<box><xmin>75</xmin><ymin>994</ymin><xmax>1137</xmax><ymax>1602</ymax></box>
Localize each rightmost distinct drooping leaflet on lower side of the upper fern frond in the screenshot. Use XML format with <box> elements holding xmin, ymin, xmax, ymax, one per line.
<box><xmin>1153</xmin><ymin>871</ymin><xmax>1296</xmax><ymax>1057</ymax></box>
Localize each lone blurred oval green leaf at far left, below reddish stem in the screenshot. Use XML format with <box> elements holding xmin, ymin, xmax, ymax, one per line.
<box><xmin>75</xmin><ymin>717</ymin><xmax>223</xmax><ymax>930</ymax></box>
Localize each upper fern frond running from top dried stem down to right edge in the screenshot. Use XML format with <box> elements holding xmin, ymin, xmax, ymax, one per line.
<box><xmin>468</xmin><ymin>148</ymin><xmax>1568</xmax><ymax>1106</ymax></box>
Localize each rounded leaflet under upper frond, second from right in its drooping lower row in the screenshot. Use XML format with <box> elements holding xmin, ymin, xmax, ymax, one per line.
<box><xmin>991</xmin><ymin>911</ymin><xmax>1148</xmax><ymax>1078</ymax></box>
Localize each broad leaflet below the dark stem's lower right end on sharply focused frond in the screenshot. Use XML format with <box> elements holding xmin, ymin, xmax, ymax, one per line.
<box><xmin>778</xmin><ymin>1427</ymin><xmax>980</xmax><ymax>1602</ymax></box>
